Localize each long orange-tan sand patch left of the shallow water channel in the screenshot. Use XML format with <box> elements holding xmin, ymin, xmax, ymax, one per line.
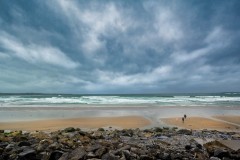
<box><xmin>0</xmin><ymin>116</ymin><xmax>151</xmax><ymax>131</ymax></box>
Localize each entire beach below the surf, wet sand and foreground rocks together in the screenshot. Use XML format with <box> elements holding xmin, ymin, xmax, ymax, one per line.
<box><xmin>0</xmin><ymin>105</ymin><xmax>240</xmax><ymax>160</ymax></box>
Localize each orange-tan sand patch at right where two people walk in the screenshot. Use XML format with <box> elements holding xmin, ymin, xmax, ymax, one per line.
<box><xmin>161</xmin><ymin>116</ymin><xmax>240</xmax><ymax>131</ymax></box>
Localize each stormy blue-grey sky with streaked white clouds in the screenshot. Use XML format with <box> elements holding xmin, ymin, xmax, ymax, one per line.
<box><xmin>0</xmin><ymin>0</ymin><xmax>240</xmax><ymax>94</ymax></box>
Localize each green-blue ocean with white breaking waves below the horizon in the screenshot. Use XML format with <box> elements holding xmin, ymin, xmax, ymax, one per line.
<box><xmin>0</xmin><ymin>92</ymin><xmax>240</xmax><ymax>107</ymax></box>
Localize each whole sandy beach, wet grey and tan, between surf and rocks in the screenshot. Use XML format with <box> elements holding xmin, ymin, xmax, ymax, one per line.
<box><xmin>0</xmin><ymin>105</ymin><xmax>240</xmax><ymax>132</ymax></box>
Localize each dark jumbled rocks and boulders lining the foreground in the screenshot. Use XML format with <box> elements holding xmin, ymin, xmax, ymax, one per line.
<box><xmin>0</xmin><ymin>127</ymin><xmax>240</xmax><ymax>160</ymax></box>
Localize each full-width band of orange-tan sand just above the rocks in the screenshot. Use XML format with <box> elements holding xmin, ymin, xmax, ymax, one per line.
<box><xmin>0</xmin><ymin>115</ymin><xmax>240</xmax><ymax>132</ymax></box>
